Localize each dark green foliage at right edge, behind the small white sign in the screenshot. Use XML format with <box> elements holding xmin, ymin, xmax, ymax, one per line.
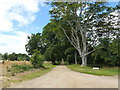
<box><xmin>92</xmin><ymin>38</ymin><xmax>120</xmax><ymax>66</ymax></box>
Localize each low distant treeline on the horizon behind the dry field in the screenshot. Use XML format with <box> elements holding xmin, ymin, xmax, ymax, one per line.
<box><xmin>1</xmin><ymin>52</ymin><xmax>30</xmax><ymax>61</ymax></box>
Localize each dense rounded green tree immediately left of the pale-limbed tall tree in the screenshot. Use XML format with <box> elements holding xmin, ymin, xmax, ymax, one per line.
<box><xmin>42</xmin><ymin>21</ymin><xmax>70</xmax><ymax>64</ymax></box>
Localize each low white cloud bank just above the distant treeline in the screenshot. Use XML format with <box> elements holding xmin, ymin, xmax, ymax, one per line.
<box><xmin>0</xmin><ymin>31</ymin><xmax>30</xmax><ymax>53</ymax></box>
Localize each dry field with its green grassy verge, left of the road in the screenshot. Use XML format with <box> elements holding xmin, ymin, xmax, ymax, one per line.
<box><xmin>0</xmin><ymin>61</ymin><xmax>55</xmax><ymax>87</ymax></box>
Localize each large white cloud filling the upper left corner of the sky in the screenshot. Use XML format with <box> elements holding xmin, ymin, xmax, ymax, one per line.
<box><xmin>0</xmin><ymin>0</ymin><xmax>40</xmax><ymax>32</ymax></box>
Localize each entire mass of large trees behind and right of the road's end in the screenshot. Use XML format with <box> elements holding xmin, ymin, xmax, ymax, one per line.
<box><xmin>26</xmin><ymin>2</ymin><xmax>120</xmax><ymax>66</ymax></box>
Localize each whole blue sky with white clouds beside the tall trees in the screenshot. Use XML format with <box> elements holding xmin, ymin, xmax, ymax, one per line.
<box><xmin>0</xmin><ymin>0</ymin><xmax>117</xmax><ymax>54</ymax></box>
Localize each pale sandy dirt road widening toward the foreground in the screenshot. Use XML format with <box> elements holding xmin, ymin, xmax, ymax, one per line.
<box><xmin>12</xmin><ymin>66</ymin><xmax>118</xmax><ymax>88</ymax></box>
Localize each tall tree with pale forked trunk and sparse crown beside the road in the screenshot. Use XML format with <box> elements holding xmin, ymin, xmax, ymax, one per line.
<box><xmin>50</xmin><ymin>2</ymin><xmax>117</xmax><ymax>66</ymax></box>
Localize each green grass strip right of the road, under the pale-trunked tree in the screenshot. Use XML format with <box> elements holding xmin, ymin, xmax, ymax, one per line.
<box><xmin>67</xmin><ymin>65</ymin><xmax>118</xmax><ymax>76</ymax></box>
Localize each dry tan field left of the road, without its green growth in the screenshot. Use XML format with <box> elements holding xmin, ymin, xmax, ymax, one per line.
<box><xmin>0</xmin><ymin>61</ymin><xmax>51</xmax><ymax>89</ymax></box>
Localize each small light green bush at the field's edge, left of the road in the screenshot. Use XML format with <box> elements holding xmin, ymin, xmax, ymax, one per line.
<box><xmin>31</xmin><ymin>49</ymin><xmax>44</xmax><ymax>68</ymax></box>
